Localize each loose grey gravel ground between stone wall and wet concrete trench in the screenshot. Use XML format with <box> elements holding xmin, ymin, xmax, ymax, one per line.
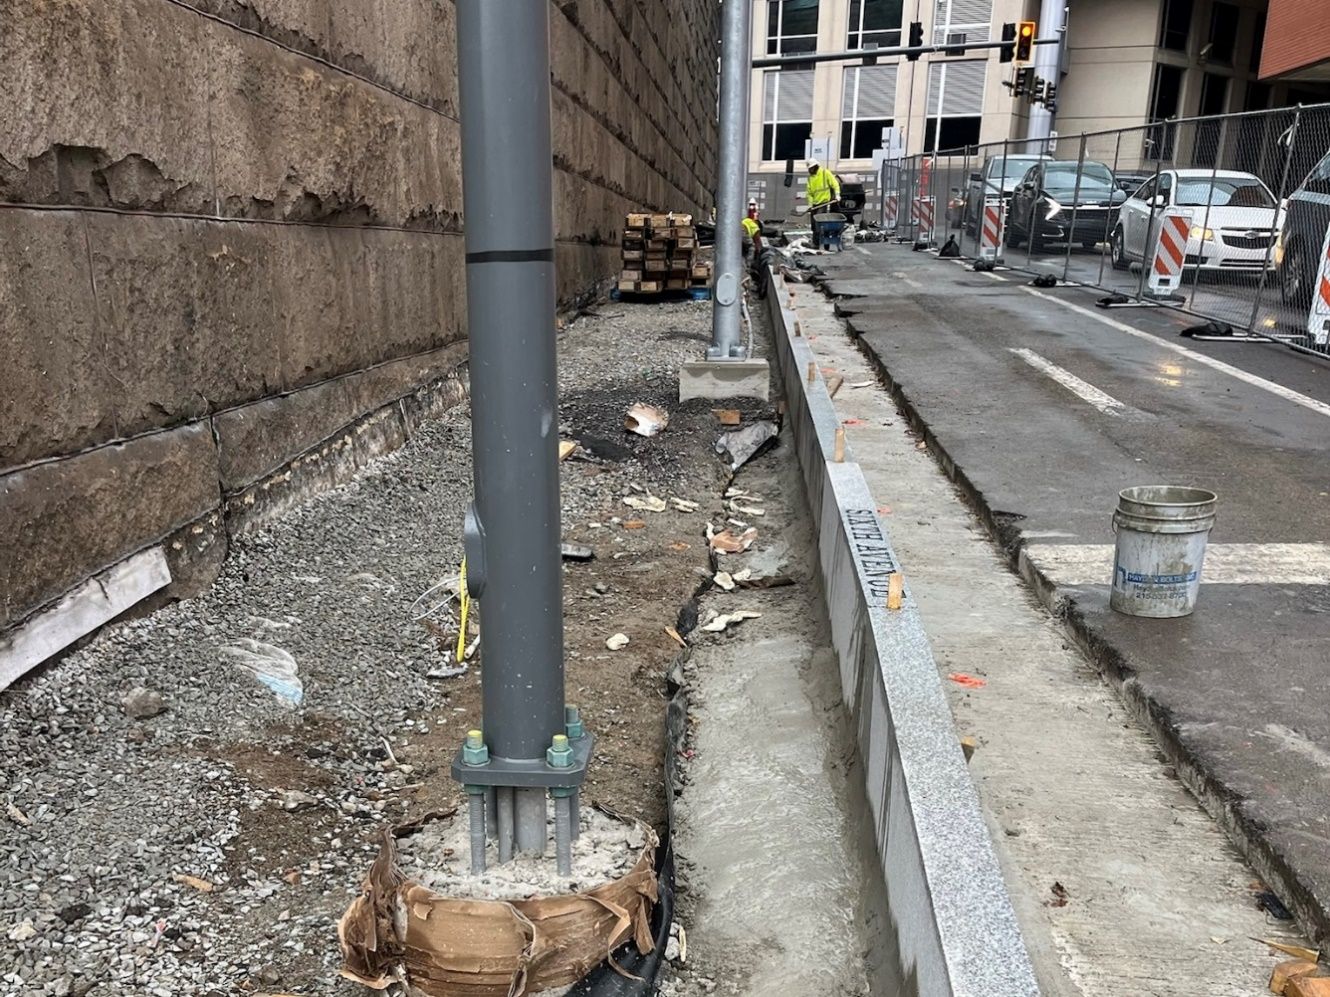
<box><xmin>0</xmin><ymin>303</ymin><xmax>760</xmax><ymax>997</ymax></box>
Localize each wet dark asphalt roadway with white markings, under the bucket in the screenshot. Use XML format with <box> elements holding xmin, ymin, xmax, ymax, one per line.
<box><xmin>817</xmin><ymin>243</ymin><xmax>1330</xmax><ymax>942</ymax></box>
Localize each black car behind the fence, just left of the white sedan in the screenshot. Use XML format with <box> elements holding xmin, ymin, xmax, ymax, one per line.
<box><xmin>1007</xmin><ymin>160</ymin><xmax>1127</xmax><ymax>253</ymax></box>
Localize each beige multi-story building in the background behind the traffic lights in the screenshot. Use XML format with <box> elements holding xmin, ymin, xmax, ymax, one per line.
<box><xmin>749</xmin><ymin>0</ymin><xmax>1330</xmax><ymax>213</ymax></box>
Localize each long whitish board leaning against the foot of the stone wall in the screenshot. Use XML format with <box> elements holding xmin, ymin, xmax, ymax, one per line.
<box><xmin>0</xmin><ymin>546</ymin><xmax>170</xmax><ymax>689</ymax></box>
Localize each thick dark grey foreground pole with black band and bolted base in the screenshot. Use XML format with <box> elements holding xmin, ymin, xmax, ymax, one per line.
<box><xmin>452</xmin><ymin>0</ymin><xmax>592</xmax><ymax>868</ymax></box>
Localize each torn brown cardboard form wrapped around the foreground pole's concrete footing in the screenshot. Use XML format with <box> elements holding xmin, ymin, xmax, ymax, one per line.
<box><xmin>338</xmin><ymin>826</ymin><xmax>660</xmax><ymax>997</ymax></box>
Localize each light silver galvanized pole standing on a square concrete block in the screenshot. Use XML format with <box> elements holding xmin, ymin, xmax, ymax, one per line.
<box><xmin>706</xmin><ymin>0</ymin><xmax>753</xmax><ymax>360</ymax></box>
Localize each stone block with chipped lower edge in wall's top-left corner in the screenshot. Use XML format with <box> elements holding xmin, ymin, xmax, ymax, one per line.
<box><xmin>0</xmin><ymin>0</ymin><xmax>213</xmax><ymax>211</ymax></box>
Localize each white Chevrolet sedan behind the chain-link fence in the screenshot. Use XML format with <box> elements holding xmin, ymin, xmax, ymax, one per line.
<box><xmin>1112</xmin><ymin>169</ymin><xmax>1283</xmax><ymax>274</ymax></box>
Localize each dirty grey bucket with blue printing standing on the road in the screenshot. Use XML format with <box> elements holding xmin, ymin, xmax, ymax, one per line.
<box><xmin>1108</xmin><ymin>485</ymin><xmax>1218</xmax><ymax>619</ymax></box>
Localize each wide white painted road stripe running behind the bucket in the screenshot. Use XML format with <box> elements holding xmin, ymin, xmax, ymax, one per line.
<box><xmin>1024</xmin><ymin>544</ymin><xmax>1330</xmax><ymax>586</ymax></box>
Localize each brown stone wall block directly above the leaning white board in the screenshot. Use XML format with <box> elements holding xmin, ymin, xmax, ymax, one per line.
<box><xmin>0</xmin><ymin>425</ymin><xmax>221</xmax><ymax>629</ymax></box>
